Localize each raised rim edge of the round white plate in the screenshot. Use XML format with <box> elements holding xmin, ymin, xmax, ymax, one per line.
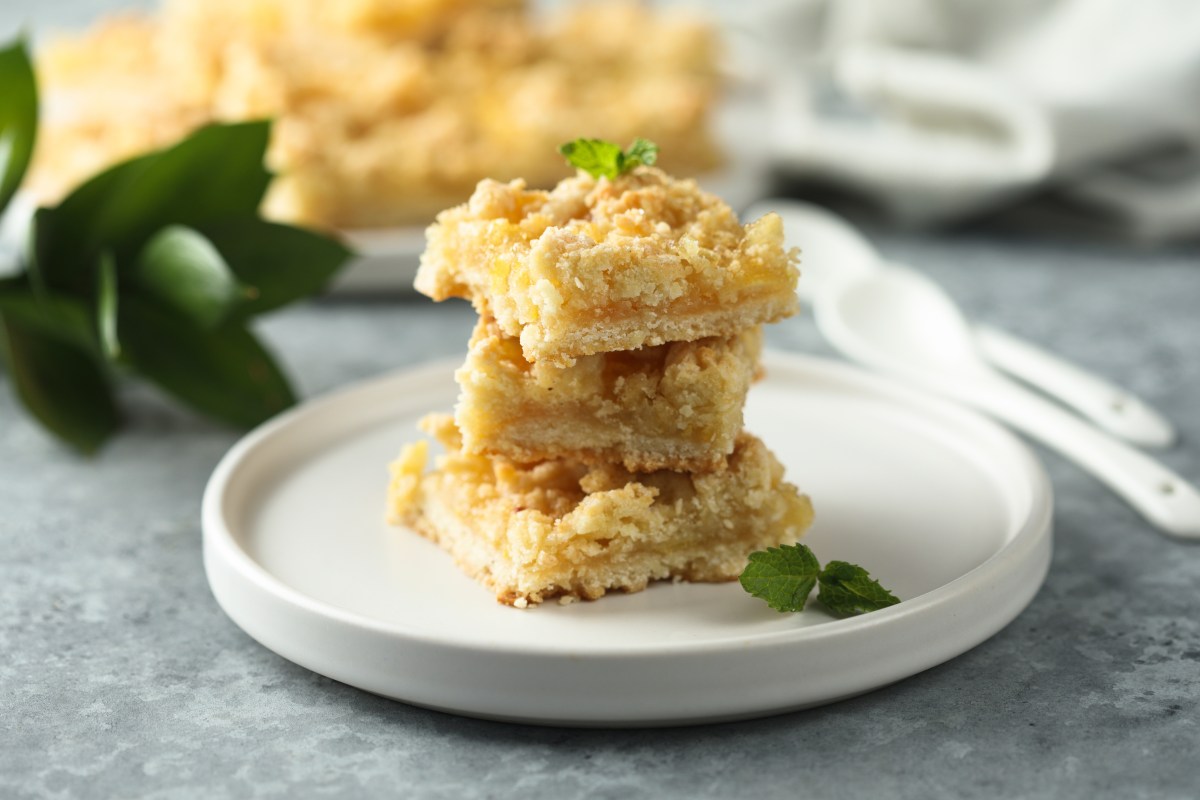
<box><xmin>202</xmin><ymin>349</ymin><xmax>1054</xmax><ymax>660</ymax></box>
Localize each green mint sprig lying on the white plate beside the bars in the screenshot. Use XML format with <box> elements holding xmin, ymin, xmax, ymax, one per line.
<box><xmin>739</xmin><ymin>545</ymin><xmax>900</xmax><ymax>616</ymax></box>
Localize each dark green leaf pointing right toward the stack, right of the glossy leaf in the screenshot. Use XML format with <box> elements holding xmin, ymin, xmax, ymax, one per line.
<box><xmin>202</xmin><ymin>217</ymin><xmax>353</xmax><ymax>318</ymax></box>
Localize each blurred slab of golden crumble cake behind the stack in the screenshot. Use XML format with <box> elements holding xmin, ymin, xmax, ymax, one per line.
<box><xmin>29</xmin><ymin>0</ymin><xmax>719</xmax><ymax>229</ymax></box>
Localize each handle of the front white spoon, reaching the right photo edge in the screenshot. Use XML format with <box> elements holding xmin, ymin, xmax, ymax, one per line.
<box><xmin>937</xmin><ymin>375</ymin><xmax>1200</xmax><ymax>540</ymax></box>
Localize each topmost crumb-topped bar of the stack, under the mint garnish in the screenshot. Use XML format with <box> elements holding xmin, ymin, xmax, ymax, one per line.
<box><xmin>415</xmin><ymin>167</ymin><xmax>799</xmax><ymax>366</ymax></box>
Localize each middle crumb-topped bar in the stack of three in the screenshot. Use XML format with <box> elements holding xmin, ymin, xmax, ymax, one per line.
<box><xmin>455</xmin><ymin>318</ymin><xmax>762</xmax><ymax>471</ymax></box>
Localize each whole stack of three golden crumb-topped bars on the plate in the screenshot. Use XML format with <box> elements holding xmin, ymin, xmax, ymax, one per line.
<box><xmin>389</xmin><ymin>167</ymin><xmax>812</xmax><ymax>607</ymax></box>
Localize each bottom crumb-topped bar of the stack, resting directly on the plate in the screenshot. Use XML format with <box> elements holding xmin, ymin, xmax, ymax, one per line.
<box><xmin>388</xmin><ymin>415</ymin><xmax>812</xmax><ymax>607</ymax></box>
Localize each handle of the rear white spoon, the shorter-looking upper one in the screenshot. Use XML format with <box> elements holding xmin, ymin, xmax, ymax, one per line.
<box><xmin>974</xmin><ymin>325</ymin><xmax>1176</xmax><ymax>447</ymax></box>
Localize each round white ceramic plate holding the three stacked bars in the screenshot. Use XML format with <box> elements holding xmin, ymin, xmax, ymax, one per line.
<box><xmin>203</xmin><ymin>354</ymin><xmax>1051</xmax><ymax>726</ymax></box>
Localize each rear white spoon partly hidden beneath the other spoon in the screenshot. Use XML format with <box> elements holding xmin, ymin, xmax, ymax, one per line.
<box><xmin>746</xmin><ymin>200</ymin><xmax>1176</xmax><ymax>447</ymax></box>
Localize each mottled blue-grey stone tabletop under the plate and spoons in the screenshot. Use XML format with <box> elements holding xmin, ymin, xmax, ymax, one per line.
<box><xmin>0</xmin><ymin>226</ymin><xmax>1200</xmax><ymax>800</ymax></box>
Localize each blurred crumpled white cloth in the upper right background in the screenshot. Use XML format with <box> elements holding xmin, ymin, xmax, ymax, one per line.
<box><xmin>743</xmin><ymin>0</ymin><xmax>1200</xmax><ymax>241</ymax></box>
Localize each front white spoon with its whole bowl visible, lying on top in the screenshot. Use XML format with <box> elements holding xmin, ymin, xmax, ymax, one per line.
<box><xmin>815</xmin><ymin>267</ymin><xmax>1200</xmax><ymax>539</ymax></box>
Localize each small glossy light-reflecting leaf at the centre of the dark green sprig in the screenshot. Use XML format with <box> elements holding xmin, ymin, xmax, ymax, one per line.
<box><xmin>130</xmin><ymin>225</ymin><xmax>244</xmax><ymax>329</ymax></box>
